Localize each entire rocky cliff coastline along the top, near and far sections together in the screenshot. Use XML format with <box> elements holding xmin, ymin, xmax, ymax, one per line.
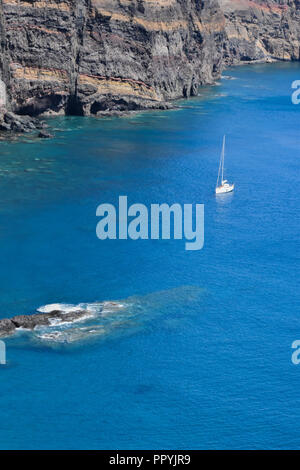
<box><xmin>0</xmin><ymin>0</ymin><xmax>300</xmax><ymax>133</ymax></box>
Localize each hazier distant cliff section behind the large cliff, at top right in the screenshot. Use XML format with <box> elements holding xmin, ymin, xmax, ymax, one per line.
<box><xmin>219</xmin><ymin>0</ymin><xmax>300</xmax><ymax>64</ymax></box>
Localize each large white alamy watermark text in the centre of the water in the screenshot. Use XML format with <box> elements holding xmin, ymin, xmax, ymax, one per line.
<box><xmin>96</xmin><ymin>196</ymin><xmax>204</xmax><ymax>251</ymax></box>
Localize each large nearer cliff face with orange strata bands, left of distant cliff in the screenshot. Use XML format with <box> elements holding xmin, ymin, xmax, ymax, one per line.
<box><xmin>1</xmin><ymin>0</ymin><xmax>224</xmax><ymax>115</ymax></box>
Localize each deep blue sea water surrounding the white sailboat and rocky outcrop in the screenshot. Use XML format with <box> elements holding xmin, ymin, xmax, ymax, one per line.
<box><xmin>0</xmin><ymin>64</ymin><xmax>300</xmax><ymax>449</ymax></box>
